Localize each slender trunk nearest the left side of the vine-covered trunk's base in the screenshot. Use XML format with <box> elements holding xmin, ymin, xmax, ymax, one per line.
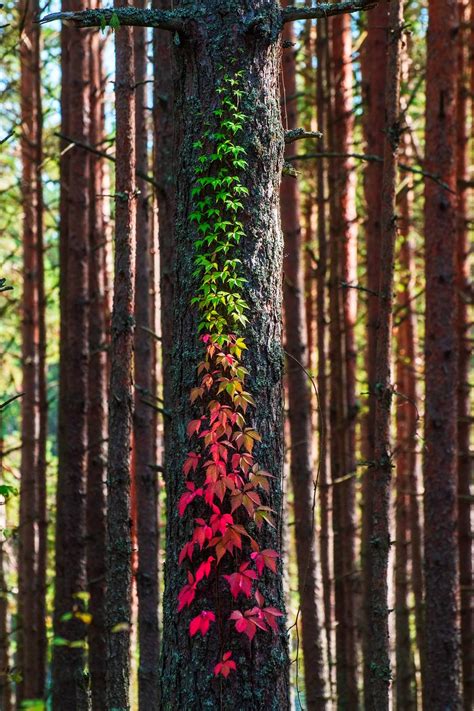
<box><xmin>133</xmin><ymin>8</ymin><xmax>161</xmax><ymax>711</ymax></box>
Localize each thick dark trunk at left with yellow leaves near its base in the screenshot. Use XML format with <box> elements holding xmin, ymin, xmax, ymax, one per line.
<box><xmin>53</xmin><ymin>0</ymin><xmax>90</xmax><ymax>711</ymax></box>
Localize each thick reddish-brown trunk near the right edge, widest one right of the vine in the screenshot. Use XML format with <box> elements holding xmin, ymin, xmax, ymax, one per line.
<box><xmin>423</xmin><ymin>0</ymin><xmax>460</xmax><ymax>711</ymax></box>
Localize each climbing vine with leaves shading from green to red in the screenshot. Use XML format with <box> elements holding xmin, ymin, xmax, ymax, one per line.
<box><xmin>178</xmin><ymin>64</ymin><xmax>283</xmax><ymax>677</ymax></box>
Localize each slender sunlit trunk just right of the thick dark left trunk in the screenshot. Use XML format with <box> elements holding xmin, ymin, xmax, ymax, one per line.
<box><xmin>87</xmin><ymin>4</ymin><xmax>107</xmax><ymax>711</ymax></box>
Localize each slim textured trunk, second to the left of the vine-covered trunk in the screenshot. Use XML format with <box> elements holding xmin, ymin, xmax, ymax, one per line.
<box><xmin>105</xmin><ymin>8</ymin><xmax>137</xmax><ymax>709</ymax></box>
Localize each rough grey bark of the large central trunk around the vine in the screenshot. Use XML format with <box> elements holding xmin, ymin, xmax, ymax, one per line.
<box><xmin>161</xmin><ymin>0</ymin><xmax>289</xmax><ymax>711</ymax></box>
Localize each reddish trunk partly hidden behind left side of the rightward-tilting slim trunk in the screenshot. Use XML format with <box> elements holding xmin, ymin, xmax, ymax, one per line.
<box><xmin>361</xmin><ymin>0</ymin><xmax>388</xmax><ymax>709</ymax></box>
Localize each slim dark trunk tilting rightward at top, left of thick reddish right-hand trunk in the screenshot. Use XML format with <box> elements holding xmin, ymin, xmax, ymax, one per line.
<box><xmin>367</xmin><ymin>0</ymin><xmax>403</xmax><ymax>711</ymax></box>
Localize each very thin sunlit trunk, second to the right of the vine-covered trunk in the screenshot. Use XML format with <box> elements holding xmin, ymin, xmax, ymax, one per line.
<box><xmin>316</xmin><ymin>20</ymin><xmax>332</xmax><ymax>698</ymax></box>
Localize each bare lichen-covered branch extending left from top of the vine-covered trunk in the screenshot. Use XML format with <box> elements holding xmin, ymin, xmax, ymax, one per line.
<box><xmin>38</xmin><ymin>7</ymin><xmax>189</xmax><ymax>32</ymax></box>
